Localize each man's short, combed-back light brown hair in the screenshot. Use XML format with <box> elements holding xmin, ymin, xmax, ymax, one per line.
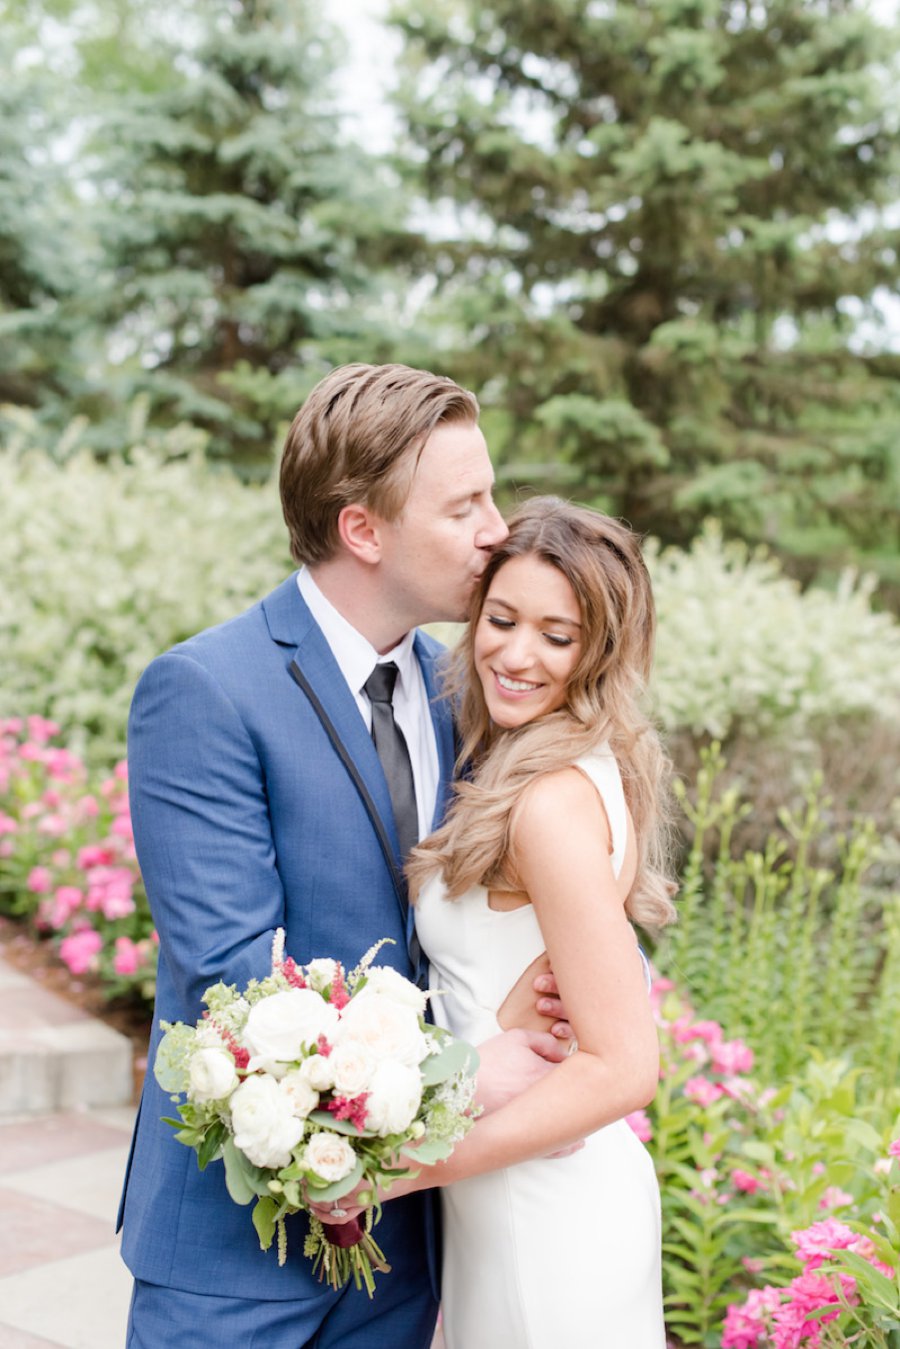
<box><xmin>281</xmin><ymin>364</ymin><xmax>479</xmax><ymax>564</ymax></box>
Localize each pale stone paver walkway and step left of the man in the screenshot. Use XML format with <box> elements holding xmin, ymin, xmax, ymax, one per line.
<box><xmin>0</xmin><ymin>959</ymin><xmax>134</xmax><ymax>1349</ymax></box>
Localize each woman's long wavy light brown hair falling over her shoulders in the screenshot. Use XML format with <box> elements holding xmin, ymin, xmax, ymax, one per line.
<box><xmin>406</xmin><ymin>496</ymin><xmax>675</xmax><ymax>928</ymax></box>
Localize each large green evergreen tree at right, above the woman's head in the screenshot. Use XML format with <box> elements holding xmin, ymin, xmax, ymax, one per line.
<box><xmin>395</xmin><ymin>0</ymin><xmax>900</xmax><ymax>581</ymax></box>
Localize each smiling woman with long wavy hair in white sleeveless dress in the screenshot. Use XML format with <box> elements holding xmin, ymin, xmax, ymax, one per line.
<box><xmin>325</xmin><ymin>498</ymin><xmax>673</xmax><ymax>1349</ymax></box>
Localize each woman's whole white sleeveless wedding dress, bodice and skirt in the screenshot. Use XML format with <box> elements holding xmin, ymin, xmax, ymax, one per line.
<box><xmin>416</xmin><ymin>746</ymin><xmax>665</xmax><ymax>1349</ymax></box>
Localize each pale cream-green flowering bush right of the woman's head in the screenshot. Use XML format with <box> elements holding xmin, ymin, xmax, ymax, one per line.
<box><xmin>648</xmin><ymin>526</ymin><xmax>900</xmax><ymax>739</ymax></box>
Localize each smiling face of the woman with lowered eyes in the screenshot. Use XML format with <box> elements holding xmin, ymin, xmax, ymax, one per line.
<box><xmin>475</xmin><ymin>556</ymin><xmax>582</xmax><ymax>730</ymax></box>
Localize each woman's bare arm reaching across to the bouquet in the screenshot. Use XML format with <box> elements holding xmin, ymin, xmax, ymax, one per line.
<box><xmin>318</xmin><ymin>769</ymin><xmax>658</xmax><ymax>1224</ymax></box>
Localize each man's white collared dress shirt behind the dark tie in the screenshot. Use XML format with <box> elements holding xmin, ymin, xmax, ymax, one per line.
<box><xmin>297</xmin><ymin>567</ymin><xmax>440</xmax><ymax>839</ymax></box>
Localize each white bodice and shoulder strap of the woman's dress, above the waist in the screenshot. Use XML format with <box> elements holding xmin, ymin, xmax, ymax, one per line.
<box><xmin>416</xmin><ymin>743</ymin><xmax>627</xmax><ymax>1041</ymax></box>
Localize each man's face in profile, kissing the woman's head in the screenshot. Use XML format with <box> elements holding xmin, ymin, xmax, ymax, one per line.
<box><xmin>379</xmin><ymin>422</ymin><xmax>507</xmax><ymax>629</ymax></box>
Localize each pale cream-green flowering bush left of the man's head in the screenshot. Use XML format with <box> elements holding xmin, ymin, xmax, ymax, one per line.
<box><xmin>0</xmin><ymin>451</ymin><xmax>290</xmax><ymax>764</ymax></box>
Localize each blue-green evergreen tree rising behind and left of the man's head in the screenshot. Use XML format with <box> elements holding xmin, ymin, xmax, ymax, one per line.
<box><xmin>89</xmin><ymin>0</ymin><xmax>415</xmax><ymax>467</ymax></box>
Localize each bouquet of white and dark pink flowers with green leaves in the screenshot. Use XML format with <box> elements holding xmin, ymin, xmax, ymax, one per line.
<box><xmin>154</xmin><ymin>929</ymin><xmax>478</xmax><ymax>1296</ymax></box>
